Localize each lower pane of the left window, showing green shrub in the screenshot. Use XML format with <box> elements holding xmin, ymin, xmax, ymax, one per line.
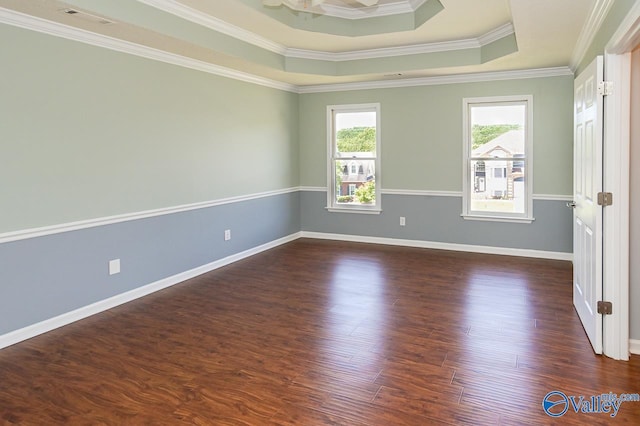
<box><xmin>335</xmin><ymin>159</ymin><xmax>376</xmax><ymax>205</ymax></box>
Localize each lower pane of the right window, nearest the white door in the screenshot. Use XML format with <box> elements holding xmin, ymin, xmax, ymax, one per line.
<box><xmin>469</xmin><ymin>160</ymin><xmax>526</xmax><ymax>213</ymax></box>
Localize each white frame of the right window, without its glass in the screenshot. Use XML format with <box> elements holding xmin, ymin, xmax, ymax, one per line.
<box><xmin>461</xmin><ymin>95</ymin><xmax>535</xmax><ymax>223</ymax></box>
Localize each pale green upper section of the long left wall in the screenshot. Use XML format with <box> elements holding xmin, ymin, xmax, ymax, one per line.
<box><xmin>0</xmin><ymin>25</ymin><xmax>299</xmax><ymax>233</ymax></box>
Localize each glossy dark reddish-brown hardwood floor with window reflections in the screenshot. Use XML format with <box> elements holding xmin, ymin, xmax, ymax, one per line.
<box><xmin>0</xmin><ymin>239</ymin><xmax>640</xmax><ymax>425</ymax></box>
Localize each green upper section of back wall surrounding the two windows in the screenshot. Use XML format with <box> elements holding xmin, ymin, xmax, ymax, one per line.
<box><xmin>299</xmin><ymin>76</ymin><xmax>573</xmax><ymax>195</ymax></box>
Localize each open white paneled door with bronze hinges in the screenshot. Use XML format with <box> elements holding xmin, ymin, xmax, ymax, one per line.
<box><xmin>573</xmin><ymin>56</ymin><xmax>603</xmax><ymax>354</ymax></box>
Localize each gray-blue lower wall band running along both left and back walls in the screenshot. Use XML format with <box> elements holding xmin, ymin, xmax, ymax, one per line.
<box><xmin>0</xmin><ymin>191</ymin><xmax>572</xmax><ymax>342</ymax></box>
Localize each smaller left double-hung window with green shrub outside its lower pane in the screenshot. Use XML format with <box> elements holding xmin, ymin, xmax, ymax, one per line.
<box><xmin>327</xmin><ymin>104</ymin><xmax>380</xmax><ymax>214</ymax></box>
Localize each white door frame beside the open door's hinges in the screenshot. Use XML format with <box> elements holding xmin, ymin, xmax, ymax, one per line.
<box><xmin>603</xmin><ymin>2</ymin><xmax>640</xmax><ymax>360</ymax></box>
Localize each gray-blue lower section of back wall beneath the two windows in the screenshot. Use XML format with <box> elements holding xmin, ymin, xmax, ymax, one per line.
<box><xmin>300</xmin><ymin>191</ymin><xmax>573</xmax><ymax>253</ymax></box>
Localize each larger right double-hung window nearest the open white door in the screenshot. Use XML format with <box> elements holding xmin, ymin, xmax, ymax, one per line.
<box><xmin>462</xmin><ymin>95</ymin><xmax>533</xmax><ymax>222</ymax></box>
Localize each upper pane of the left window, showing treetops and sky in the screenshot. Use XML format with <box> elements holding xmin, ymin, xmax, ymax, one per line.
<box><xmin>335</xmin><ymin>111</ymin><xmax>376</xmax><ymax>157</ymax></box>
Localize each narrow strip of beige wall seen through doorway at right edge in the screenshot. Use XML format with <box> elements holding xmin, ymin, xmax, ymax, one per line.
<box><xmin>629</xmin><ymin>47</ymin><xmax>640</xmax><ymax>340</ymax></box>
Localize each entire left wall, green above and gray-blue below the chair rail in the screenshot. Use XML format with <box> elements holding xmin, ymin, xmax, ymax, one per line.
<box><xmin>0</xmin><ymin>25</ymin><xmax>300</xmax><ymax>340</ymax></box>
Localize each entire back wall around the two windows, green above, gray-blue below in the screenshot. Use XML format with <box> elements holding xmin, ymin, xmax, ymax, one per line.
<box><xmin>300</xmin><ymin>76</ymin><xmax>573</xmax><ymax>253</ymax></box>
